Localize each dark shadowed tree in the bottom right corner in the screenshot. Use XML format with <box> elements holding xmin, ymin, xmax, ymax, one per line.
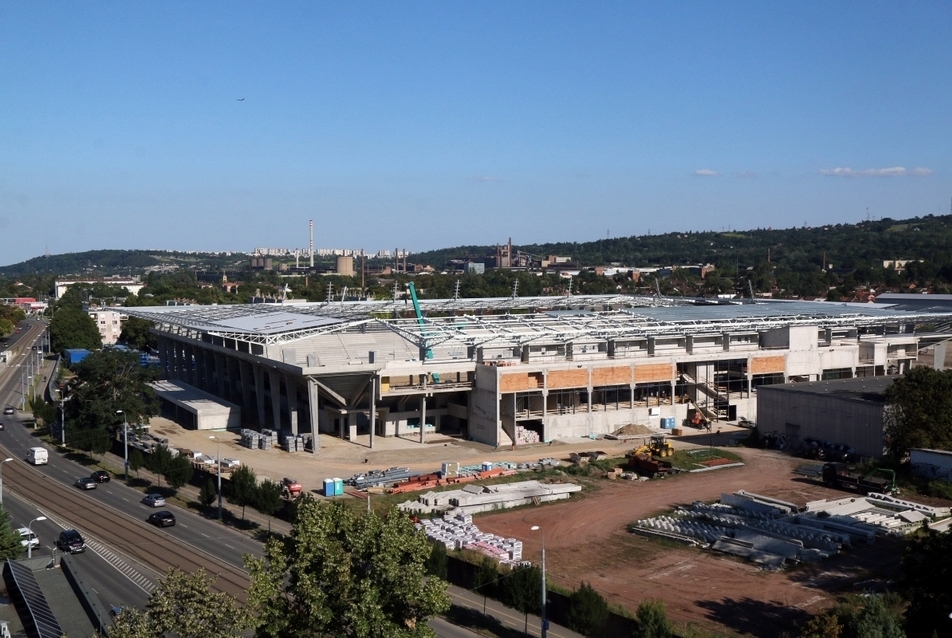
<box><xmin>899</xmin><ymin>530</ymin><xmax>952</xmax><ymax>637</ymax></box>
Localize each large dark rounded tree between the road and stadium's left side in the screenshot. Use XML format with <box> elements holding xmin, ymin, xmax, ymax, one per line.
<box><xmin>66</xmin><ymin>349</ymin><xmax>158</xmax><ymax>453</ymax></box>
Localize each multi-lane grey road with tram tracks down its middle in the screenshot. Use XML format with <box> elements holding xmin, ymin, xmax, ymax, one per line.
<box><xmin>0</xmin><ymin>322</ymin><xmax>475</xmax><ymax>638</ymax></box>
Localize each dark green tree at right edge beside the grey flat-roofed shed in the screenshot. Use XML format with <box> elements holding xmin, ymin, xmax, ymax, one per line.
<box><xmin>883</xmin><ymin>366</ymin><xmax>952</xmax><ymax>460</ymax></box>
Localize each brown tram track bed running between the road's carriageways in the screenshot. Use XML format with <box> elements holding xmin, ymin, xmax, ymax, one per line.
<box><xmin>4</xmin><ymin>463</ymin><xmax>249</xmax><ymax>602</ymax></box>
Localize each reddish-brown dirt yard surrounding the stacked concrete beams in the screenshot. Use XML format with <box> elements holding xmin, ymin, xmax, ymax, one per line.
<box><xmin>477</xmin><ymin>449</ymin><xmax>899</xmax><ymax>636</ymax></box>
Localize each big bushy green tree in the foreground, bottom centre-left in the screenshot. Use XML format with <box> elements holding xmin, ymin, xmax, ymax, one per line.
<box><xmin>245</xmin><ymin>496</ymin><xmax>450</xmax><ymax>638</ymax></box>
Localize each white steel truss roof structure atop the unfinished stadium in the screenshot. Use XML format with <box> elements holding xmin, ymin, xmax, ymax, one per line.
<box><xmin>125</xmin><ymin>295</ymin><xmax>952</xmax><ymax>348</ymax></box>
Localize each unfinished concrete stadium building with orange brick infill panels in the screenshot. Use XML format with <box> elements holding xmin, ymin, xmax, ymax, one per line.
<box><xmin>122</xmin><ymin>296</ymin><xmax>952</xmax><ymax>447</ymax></box>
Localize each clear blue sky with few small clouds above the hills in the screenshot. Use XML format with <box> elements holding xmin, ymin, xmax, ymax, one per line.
<box><xmin>0</xmin><ymin>0</ymin><xmax>952</xmax><ymax>265</ymax></box>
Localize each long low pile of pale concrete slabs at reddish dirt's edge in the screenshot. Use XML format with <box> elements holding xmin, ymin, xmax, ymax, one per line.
<box><xmin>397</xmin><ymin>481</ymin><xmax>582</xmax><ymax>514</ymax></box>
